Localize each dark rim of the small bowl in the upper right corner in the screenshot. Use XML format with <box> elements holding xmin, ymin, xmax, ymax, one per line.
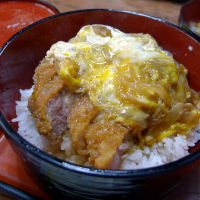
<box><xmin>179</xmin><ymin>0</ymin><xmax>200</xmax><ymax>43</ymax></box>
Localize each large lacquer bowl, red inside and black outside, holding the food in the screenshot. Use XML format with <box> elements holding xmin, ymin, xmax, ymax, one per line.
<box><xmin>0</xmin><ymin>10</ymin><xmax>200</xmax><ymax>200</ymax></box>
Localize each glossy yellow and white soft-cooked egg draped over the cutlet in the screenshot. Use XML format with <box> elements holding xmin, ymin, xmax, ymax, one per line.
<box><xmin>47</xmin><ymin>25</ymin><xmax>200</xmax><ymax>145</ymax></box>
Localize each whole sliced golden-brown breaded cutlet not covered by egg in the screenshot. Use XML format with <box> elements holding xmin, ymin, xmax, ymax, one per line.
<box><xmin>28</xmin><ymin>59</ymin><xmax>128</xmax><ymax>169</ymax></box>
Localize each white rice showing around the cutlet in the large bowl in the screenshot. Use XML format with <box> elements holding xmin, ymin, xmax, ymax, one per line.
<box><xmin>12</xmin><ymin>88</ymin><xmax>200</xmax><ymax>170</ymax></box>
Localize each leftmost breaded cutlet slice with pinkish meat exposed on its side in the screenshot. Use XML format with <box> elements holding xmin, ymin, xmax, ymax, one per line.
<box><xmin>28</xmin><ymin>59</ymin><xmax>77</xmax><ymax>138</ymax></box>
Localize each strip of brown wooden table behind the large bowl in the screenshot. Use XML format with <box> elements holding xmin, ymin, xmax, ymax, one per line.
<box><xmin>47</xmin><ymin>0</ymin><xmax>182</xmax><ymax>25</ymax></box>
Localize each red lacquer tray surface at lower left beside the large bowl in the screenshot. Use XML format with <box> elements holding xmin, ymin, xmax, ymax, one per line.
<box><xmin>0</xmin><ymin>130</ymin><xmax>52</xmax><ymax>200</ymax></box>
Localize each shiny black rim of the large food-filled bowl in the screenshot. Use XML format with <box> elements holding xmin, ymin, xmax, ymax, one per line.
<box><xmin>0</xmin><ymin>9</ymin><xmax>200</xmax><ymax>178</ymax></box>
